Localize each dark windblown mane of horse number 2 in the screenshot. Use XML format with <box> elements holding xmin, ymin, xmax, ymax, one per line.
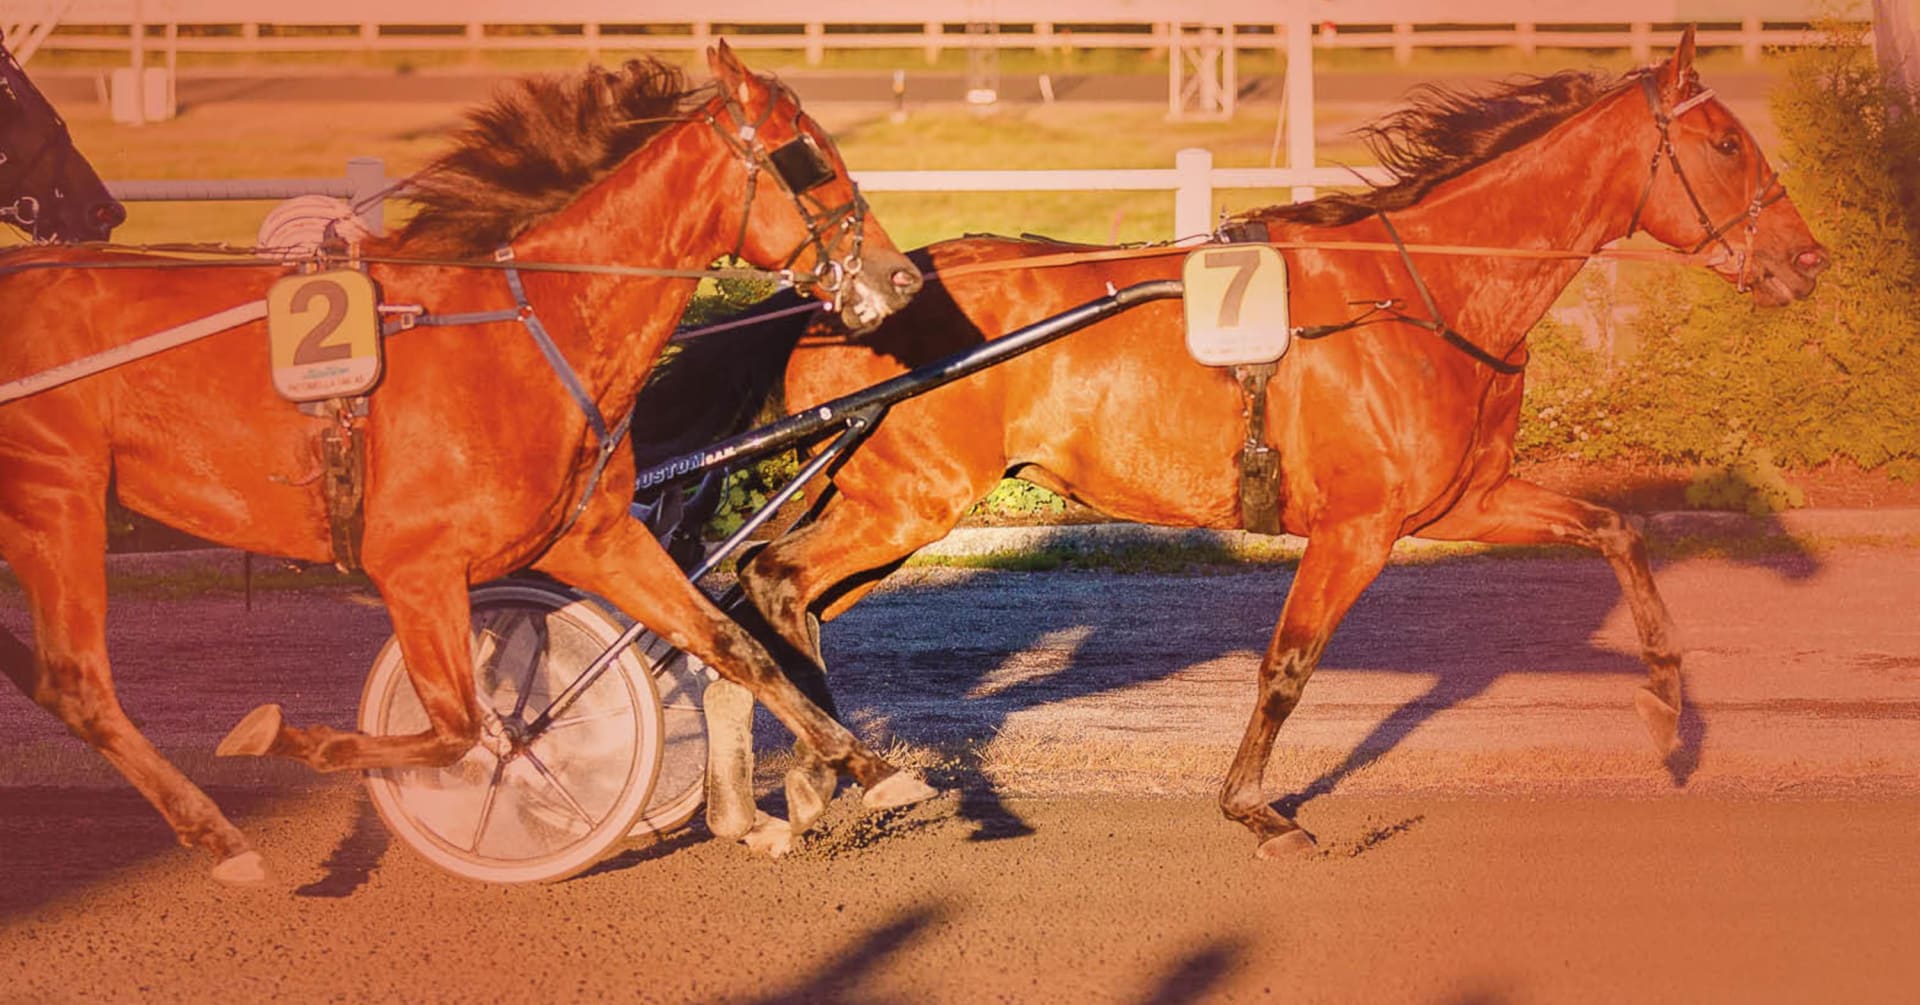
<box><xmin>396</xmin><ymin>58</ymin><xmax>703</xmax><ymax>257</ymax></box>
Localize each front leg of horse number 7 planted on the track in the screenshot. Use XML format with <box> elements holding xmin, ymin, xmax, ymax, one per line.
<box><xmin>1219</xmin><ymin>517</ymin><xmax>1400</xmax><ymax>859</ymax></box>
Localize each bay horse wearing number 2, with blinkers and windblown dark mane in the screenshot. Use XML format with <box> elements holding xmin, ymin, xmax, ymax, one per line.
<box><xmin>0</xmin><ymin>42</ymin><xmax>931</xmax><ymax>882</ymax></box>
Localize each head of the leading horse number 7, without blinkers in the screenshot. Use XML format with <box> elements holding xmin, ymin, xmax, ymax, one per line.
<box><xmin>1628</xmin><ymin>27</ymin><xmax>1832</xmax><ymax>306</ymax></box>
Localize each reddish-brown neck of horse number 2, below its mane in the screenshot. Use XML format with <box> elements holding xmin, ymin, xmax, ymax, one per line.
<box><xmin>513</xmin><ymin>121</ymin><xmax>743</xmax><ymax>415</ymax></box>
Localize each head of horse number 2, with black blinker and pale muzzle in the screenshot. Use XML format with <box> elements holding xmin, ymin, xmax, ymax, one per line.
<box><xmin>707</xmin><ymin>42</ymin><xmax>922</xmax><ymax>332</ymax></box>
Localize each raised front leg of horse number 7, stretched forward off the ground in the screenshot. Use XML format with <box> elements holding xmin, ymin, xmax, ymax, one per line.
<box><xmin>1419</xmin><ymin>478</ymin><xmax>1682</xmax><ymax>757</ymax></box>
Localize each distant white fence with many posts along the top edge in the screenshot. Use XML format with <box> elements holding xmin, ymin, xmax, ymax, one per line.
<box><xmin>8</xmin><ymin>0</ymin><xmax>1828</xmax><ymax>61</ymax></box>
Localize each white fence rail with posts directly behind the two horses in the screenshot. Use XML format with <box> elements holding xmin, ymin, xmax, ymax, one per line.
<box><xmin>108</xmin><ymin>148</ymin><xmax>1386</xmax><ymax>238</ymax></box>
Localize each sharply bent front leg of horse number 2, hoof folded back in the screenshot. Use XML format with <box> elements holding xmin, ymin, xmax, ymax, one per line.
<box><xmin>217</xmin><ymin>555</ymin><xmax>480</xmax><ymax>771</ymax></box>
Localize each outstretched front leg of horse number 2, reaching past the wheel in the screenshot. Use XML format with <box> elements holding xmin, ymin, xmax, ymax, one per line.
<box><xmin>536</xmin><ymin>513</ymin><xmax>935</xmax><ymax>841</ymax></box>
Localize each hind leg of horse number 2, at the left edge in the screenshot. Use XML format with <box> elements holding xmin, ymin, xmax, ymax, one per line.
<box><xmin>0</xmin><ymin>499</ymin><xmax>267</xmax><ymax>884</ymax></box>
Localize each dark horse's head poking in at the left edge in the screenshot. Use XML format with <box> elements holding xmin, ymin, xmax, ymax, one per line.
<box><xmin>0</xmin><ymin>38</ymin><xmax>127</xmax><ymax>240</ymax></box>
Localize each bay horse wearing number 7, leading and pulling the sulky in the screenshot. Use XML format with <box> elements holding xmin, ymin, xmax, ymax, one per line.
<box><xmin>636</xmin><ymin>31</ymin><xmax>1828</xmax><ymax>857</ymax></box>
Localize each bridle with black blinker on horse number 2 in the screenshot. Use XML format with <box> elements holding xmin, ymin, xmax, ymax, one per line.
<box><xmin>703</xmin><ymin>81</ymin><xmax>866</xmax><ymax>309</ymax></box>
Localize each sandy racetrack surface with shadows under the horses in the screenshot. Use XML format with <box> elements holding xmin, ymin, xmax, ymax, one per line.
<box><xmin>0</xmin><ymin>546</ymin><xmax>1920</xmax><ymax>1003</ymax></box>
